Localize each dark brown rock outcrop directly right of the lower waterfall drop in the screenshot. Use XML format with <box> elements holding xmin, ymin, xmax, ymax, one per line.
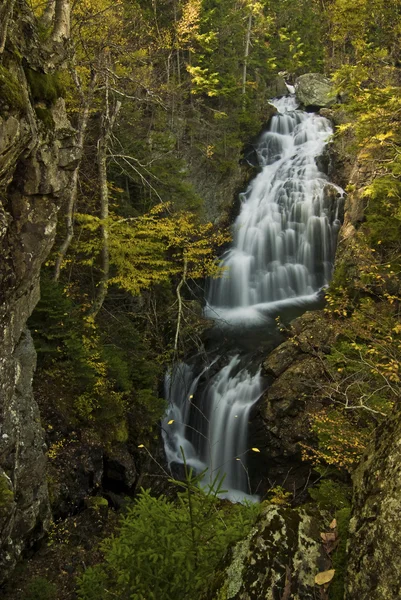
<box><xmin>248</xmin><ymin>311</ymin><xmax>333</xmax><ymax>499</ymax></box>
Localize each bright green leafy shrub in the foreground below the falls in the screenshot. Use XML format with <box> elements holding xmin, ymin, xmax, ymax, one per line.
<box><xmin>78</xmin><ymin>464</ymin><xmax>259</xmax><ymax>600</ymax></box>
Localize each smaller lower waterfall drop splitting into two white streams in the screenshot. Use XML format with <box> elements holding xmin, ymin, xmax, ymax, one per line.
<box><xmin>163</xmin><ymin>355</ymin><xmax>263</xmax><ymax>502</ymax></box>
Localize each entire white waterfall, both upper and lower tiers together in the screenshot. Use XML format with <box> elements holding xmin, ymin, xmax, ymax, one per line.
<box><xmin>163</xmin><ymin>95</ymin><xmax>343</xmax><ymax>501</ymax></box>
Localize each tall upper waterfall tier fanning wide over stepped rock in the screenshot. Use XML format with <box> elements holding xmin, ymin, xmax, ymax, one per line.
<box><xmin>206</xmin><ymin>95</ymin><xmax>342</xmax><ymax>322</ymax></box>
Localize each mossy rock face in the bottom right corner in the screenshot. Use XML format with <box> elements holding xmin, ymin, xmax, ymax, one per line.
<box><xmin>345</xmin><ymin>411</ymin><xmax>401</xmax><ymax>600</ymax></box>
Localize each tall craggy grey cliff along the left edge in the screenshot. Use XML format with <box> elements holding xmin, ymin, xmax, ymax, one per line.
<box><xmin>0</xmin><ymin>3</ymin><xmax>77</xmax><ymax>582</ymax></box>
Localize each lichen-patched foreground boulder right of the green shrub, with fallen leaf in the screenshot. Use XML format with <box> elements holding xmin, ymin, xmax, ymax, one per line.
<box><xmin>204</xmin><ymin>505</ymin><xmax>328</xmax><ymax>600</ymax></box>
